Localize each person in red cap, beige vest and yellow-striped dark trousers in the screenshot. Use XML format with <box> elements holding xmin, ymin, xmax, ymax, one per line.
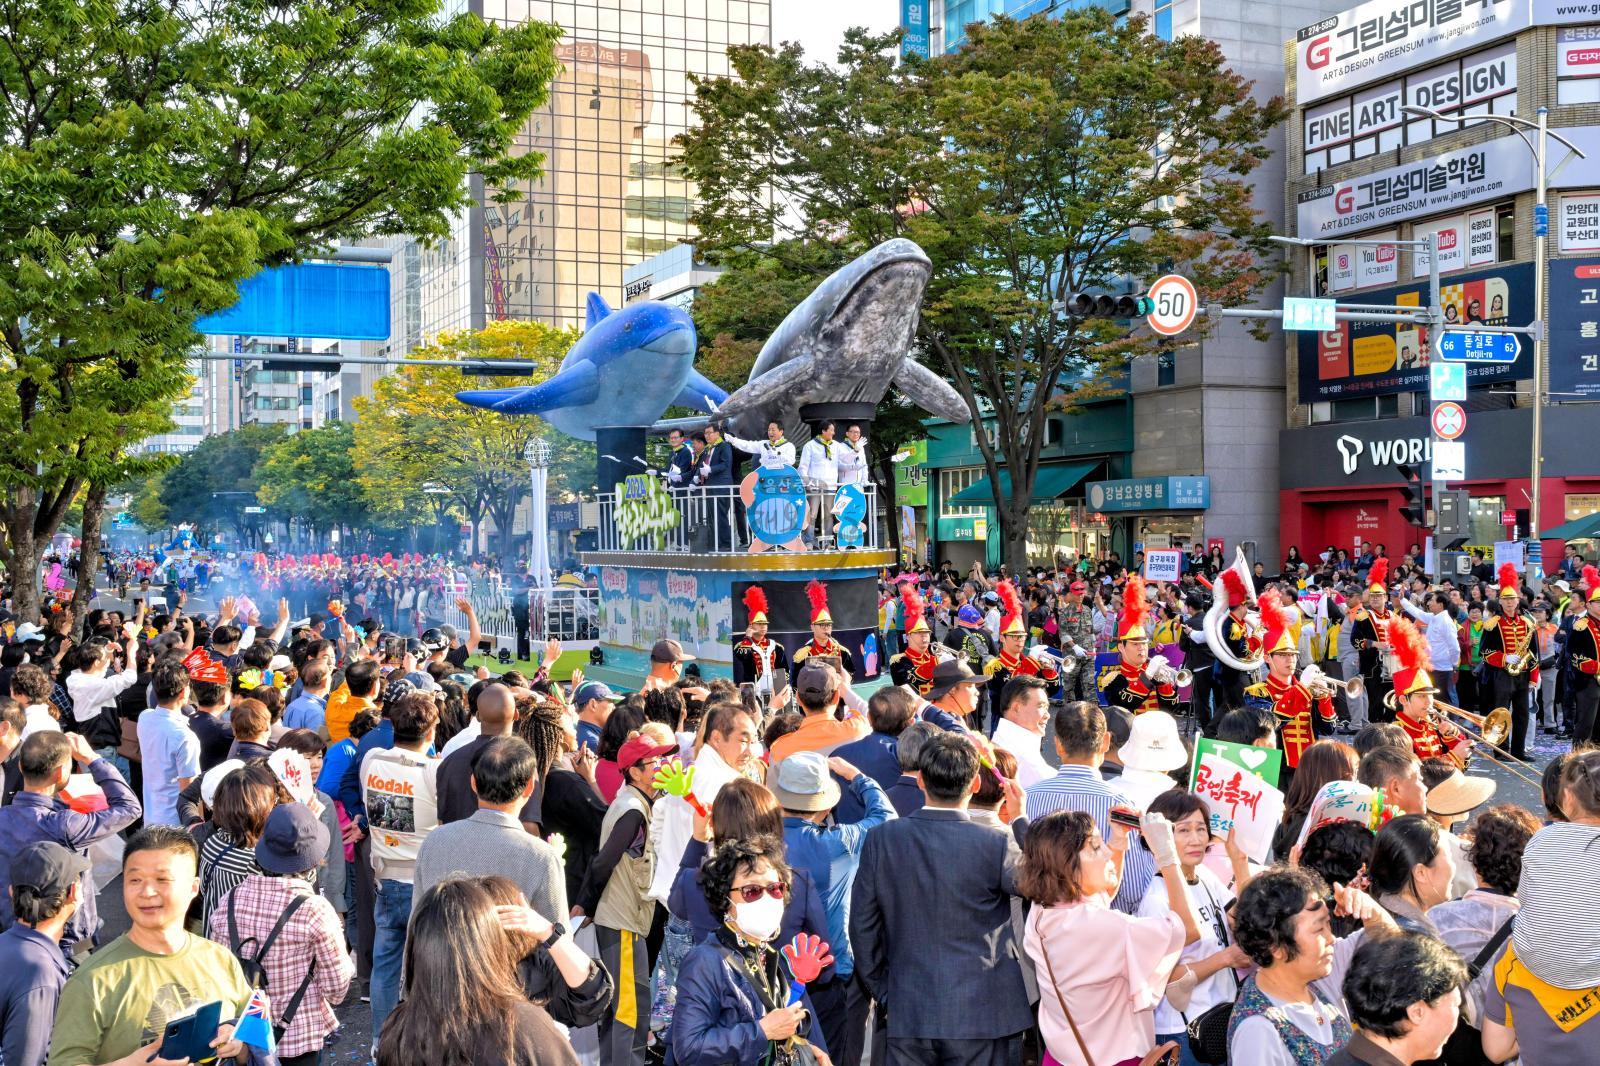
<box><xmin>573</xmin><ymin>726</ymin><xmax>678</xmax><ymax>1066</ymax></box>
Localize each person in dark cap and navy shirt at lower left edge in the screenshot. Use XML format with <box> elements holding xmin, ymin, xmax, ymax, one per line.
<box><xmin>0</xmin><ymin>840</ymin><xmax>90</xmax><ymax>1066</ymax></box>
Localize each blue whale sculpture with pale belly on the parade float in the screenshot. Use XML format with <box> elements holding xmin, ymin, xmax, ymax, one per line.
<box><xmin>456</xmin><ymin>293</ymin><xmax>728</xmax><ymax>440</ymax></box>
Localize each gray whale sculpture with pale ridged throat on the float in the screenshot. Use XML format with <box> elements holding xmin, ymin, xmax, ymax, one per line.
<box><xmin>701</xmin><ymin>237</ymin><xmax>971</xmax><ymax>440</ymax></box>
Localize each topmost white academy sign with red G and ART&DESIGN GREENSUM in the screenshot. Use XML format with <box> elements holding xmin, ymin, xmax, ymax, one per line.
<box><xmin>1294</xmin><ymin>0</ymin><xmax>1530</xmax><ymax>104</ymax></box>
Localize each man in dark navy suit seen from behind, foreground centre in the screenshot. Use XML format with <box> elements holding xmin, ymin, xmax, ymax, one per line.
<box><xmin>850</xmin><ymin>733</ymin><xmax>1034</xmax><ymax>1066</ymax></box>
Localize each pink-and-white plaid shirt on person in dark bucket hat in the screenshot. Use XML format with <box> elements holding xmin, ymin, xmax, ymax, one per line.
<box><xmin>210</xmin><ymin>874</ymin><xmax>355</xmax><ymax>1058</ymax></box>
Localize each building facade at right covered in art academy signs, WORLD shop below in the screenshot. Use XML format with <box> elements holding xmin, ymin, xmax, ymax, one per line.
<box><xmin>1278</xmin><ymin>0</ymin><xmax>1600</xmax><ymax>559</ymax></box>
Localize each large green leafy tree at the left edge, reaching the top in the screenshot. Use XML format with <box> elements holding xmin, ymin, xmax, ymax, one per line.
<box><xmin>0</xmin><ymin>0</ymin><xmax>560</xmax><ymax>619</ymax></box>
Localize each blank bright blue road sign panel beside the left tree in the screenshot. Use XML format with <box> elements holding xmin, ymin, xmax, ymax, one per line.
<box><xmin>195</xmin><ymin>262</ymin><xmax>389</xmax><ymax>341</ymax></box>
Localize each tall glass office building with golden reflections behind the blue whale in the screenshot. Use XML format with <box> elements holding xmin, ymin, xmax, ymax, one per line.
<box><xmin>387</xmin><ymin>0</ymin><xmax>771</xmax><ymax>344</ymax></box>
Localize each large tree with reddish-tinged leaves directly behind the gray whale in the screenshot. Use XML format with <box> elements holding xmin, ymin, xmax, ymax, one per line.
<box><xmin>680</xmin><ymin>8</ymin><xmax>1285</xmax><ymax>570</ymax></box>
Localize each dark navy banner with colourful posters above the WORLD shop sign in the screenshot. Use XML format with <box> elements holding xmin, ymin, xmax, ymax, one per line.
<box><xmin>1299</xmin><ymin>262</ymin><xmax>1529</xmax><ymax>403</ymax></box>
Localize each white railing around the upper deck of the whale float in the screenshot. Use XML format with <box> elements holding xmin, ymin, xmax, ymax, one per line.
<box><xmin>598</xmin><ymin>482</ymin><xmax>882</xmax><ymax>555</ymax></box>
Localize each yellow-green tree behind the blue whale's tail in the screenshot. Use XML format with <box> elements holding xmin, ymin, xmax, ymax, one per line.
<box><xmin>355</xmin><ymin>322</ymin><xmax>594</xmax><ymax>560</ymax></box>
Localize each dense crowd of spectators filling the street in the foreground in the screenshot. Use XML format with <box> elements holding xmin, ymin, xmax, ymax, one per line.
<box><xmin>0</xmin><ymin>541</ymin><xmax>1600</xmax><ymax>1066</ymax></box>
